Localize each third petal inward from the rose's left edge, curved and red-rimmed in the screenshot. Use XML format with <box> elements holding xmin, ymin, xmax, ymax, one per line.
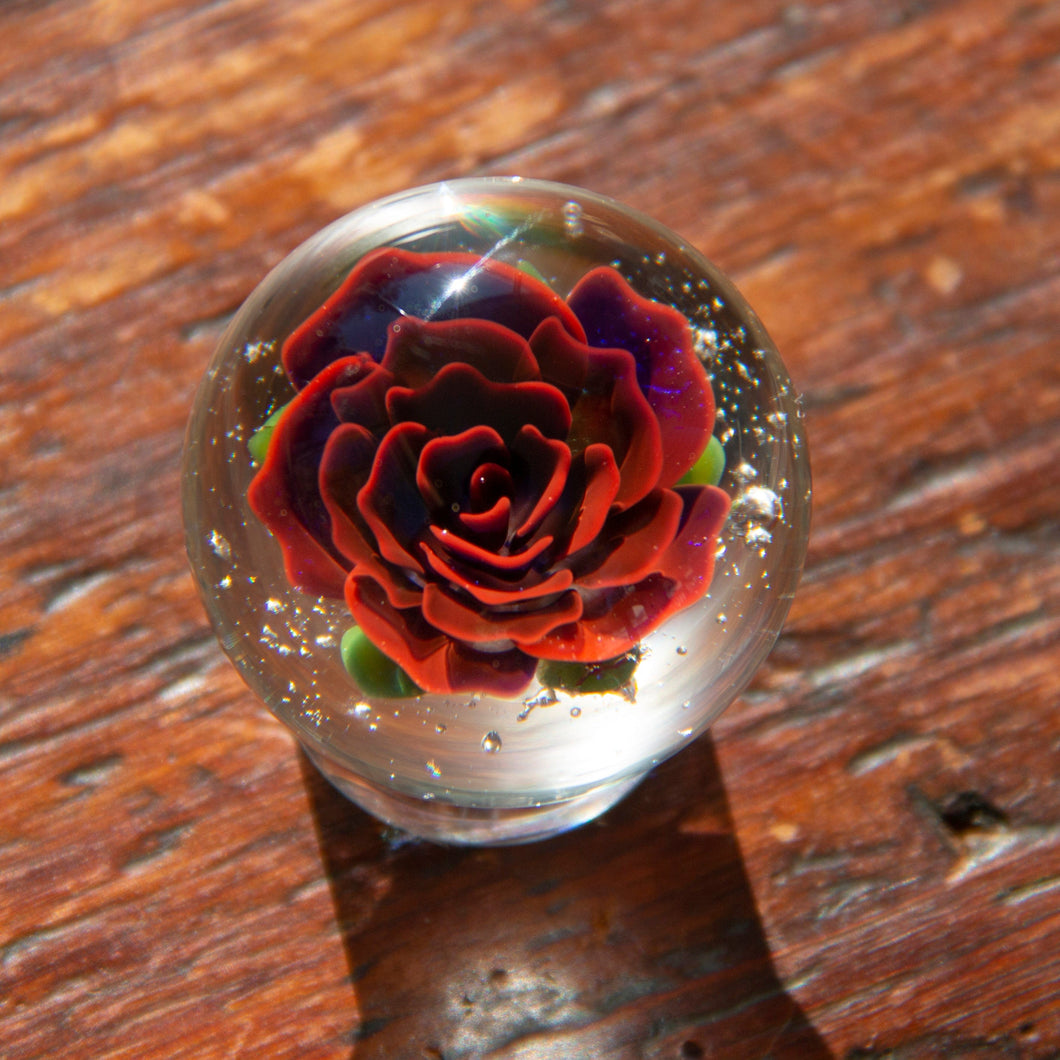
<box><xmin>357</xmin><ymin>423</ymin><xmax>431</xmax><ymax>569</ymax></box>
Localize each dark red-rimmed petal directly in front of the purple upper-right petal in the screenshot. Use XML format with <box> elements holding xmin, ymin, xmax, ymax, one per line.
<box><xmin>530</xmin><ymin>320</ymin><xmax>663</xmax><ymax>507</ymax></box>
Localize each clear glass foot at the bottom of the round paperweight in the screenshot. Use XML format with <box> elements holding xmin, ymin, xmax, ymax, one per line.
<box><xmin>303</xmin><ymin>745</ymin><xmax>648</xmax><ymax>847</ymax></box>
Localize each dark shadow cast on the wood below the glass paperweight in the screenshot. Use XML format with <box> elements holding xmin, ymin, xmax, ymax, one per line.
<box><xmin>302</xmin><ymin>736</ymin><xmax>830</xmax><ymax>1060</ymax></box>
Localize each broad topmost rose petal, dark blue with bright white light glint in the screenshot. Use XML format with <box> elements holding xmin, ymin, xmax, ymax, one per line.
<box><xmin>283</xmin><ymin>247</ymin><xmax>585</xmax><ymax>389</ymax></box>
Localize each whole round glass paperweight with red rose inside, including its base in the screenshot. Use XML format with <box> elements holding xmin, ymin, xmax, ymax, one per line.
<box><xmin>182</xmin><ymin>177</ymin><xmax>810</xmax><ymax>844</ymax></box>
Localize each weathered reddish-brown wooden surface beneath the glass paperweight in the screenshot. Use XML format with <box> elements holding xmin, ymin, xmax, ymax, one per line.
<box><xmin>0</xmin><ymin>0</ymin><xmax>1060</xmax><ymax>1060</ymax></box>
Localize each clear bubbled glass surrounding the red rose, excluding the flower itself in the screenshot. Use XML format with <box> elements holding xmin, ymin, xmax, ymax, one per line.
<box><xmin>183</xmin><ymin>178</ymin><xmax>810</xmax><ymax>843</ymax></box>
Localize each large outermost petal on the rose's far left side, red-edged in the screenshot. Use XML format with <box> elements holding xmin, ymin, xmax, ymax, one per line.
<box><xmin>247</xmin><ymin>357</ymin><xmax>375</xmax><ymax>597</ymax></box>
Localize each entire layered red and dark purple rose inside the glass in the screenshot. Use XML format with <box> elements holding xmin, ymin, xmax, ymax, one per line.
<box><xmin>249</xmin><ymin>249</ymin><xmax>729</xmax><ymax>695</ymax></box>
